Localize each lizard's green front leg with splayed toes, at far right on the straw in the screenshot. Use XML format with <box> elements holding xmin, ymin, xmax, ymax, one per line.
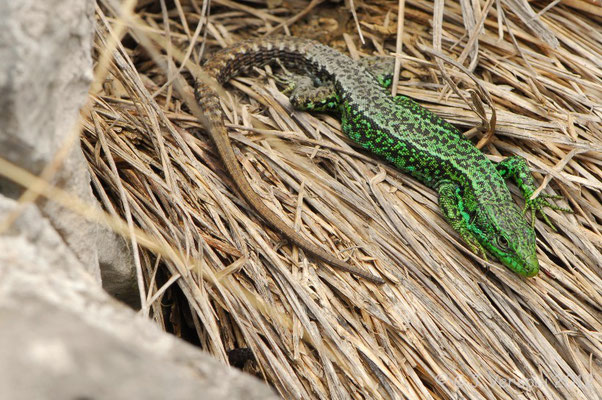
<box><xmin>495</xmin><ymin>156</ymin><xmax>573</xmax><ymax>230</ymax></box>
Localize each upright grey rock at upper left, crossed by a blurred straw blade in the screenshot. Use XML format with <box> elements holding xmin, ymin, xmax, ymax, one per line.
<box><xmin>0</xmin><ymin>0</ymin><xmax>136</xmax><ymax>304</ymax></box>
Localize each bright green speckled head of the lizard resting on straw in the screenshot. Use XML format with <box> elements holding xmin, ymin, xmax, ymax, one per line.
<box><xmin>471</xmin><ymin>203</ymin><xmax>539</xmax><ymax>277</ymax></box>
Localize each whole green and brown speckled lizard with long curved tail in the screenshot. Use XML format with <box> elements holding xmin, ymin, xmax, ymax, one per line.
<box><xmin>196</xmin><ymin>36</ymin><xmax>571</xmax><ymax>284</ymax></box>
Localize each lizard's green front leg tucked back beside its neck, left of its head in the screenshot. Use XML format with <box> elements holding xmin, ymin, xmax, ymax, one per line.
<box><xmin>437</xmin><ymin>181</ymin><xmax>487</xmax><ymax>259</ymax></box>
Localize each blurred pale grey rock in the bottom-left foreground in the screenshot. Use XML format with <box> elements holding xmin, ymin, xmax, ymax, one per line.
<box><xmin>0</xmin><ymin>198</ymin><xmax>277</xmax><ymax>400</ymax></box>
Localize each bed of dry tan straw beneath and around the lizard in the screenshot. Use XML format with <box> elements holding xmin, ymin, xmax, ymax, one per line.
<box><xmin>82</xmin><ymin>0</ymin><xmax>602</xmax><ymax>399</ymax></box>
